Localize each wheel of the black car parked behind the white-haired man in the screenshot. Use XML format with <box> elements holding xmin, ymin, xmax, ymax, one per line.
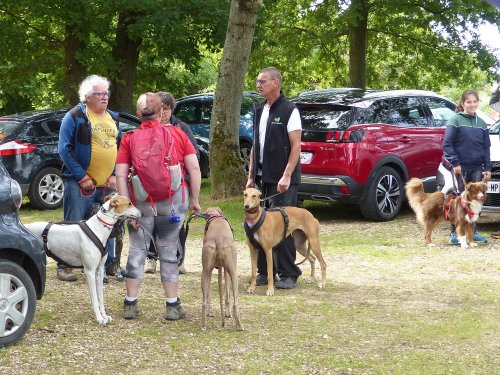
<box><xmin>28</xmin><ymin>167</ymin><xmax>64</xmax><ymax>210</ymax></box>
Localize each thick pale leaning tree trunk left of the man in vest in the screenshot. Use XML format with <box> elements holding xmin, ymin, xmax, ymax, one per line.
<box><xmin>210</xmin><ymin>0</ymin><xmax>263</xmax><ymax>199</ymax></box>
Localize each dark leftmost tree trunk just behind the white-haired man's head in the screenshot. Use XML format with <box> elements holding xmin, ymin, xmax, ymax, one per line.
<box><xmin>63</xmin><ymin>25</ymin><xmax>87</xmax><ymax>105</ymax></box>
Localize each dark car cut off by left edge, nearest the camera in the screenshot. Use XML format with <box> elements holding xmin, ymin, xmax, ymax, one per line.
<box><xmin>0</xmin><ymin>160</ymin><xmax>46</xmax><ymax>347</ymax></box>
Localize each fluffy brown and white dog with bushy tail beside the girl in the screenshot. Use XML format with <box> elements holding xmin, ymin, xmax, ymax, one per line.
<box><xmin>405</xmin><ymin>178</ymin><xmax>486</xmax><ymax>248</ymax></box>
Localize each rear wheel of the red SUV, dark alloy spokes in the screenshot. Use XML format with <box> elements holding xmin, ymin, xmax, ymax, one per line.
<box><xmin>360</xmin><ymin>167</ymin><xmax>403</xmax><ymax>221</ymax></box>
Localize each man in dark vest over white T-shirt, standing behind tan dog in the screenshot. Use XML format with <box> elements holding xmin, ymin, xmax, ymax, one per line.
<box><xmin>246</xmin><ymin>67</ymin><xmax>302</xmax><ymax>289</ymax></box>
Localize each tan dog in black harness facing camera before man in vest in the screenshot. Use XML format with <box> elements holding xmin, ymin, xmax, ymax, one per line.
<box><xmin>243</xmin><ymin>188</ymin><xmax>326</xmax><ymax>296</ymax></box>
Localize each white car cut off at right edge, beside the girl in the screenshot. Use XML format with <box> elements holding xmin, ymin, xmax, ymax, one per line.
<box><xmin>482</xmin><ymin>120</ymin><xmax>500</xmax><ymax>212</ymax></box>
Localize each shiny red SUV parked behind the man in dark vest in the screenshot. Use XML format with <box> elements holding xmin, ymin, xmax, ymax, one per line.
<box><xmin>292</xmin><ymin>89</ymin><xmax>493</xmax><ymax>221</ymax></box>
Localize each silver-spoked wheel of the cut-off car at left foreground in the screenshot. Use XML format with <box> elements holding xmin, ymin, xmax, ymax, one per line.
<box><xmin>0</xmin><ymin>260</ymin><xmax>36</xmax><ymax>347</ymax></box>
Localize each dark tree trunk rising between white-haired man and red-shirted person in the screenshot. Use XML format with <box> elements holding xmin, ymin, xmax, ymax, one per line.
<box><xmin>109</xmin><ymin>10</ymin><xmax>142</xmax><ymax>113</ymax></box>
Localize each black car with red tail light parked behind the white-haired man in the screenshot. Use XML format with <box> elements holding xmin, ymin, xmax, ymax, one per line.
<box><xmin>0</xmin><ymin>108</ymin><xmax>208</xmax><ymax>209</ymax></box>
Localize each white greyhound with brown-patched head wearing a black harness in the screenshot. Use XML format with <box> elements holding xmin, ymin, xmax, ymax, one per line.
<box><xmin>25</xmin><ymin>195</ymin><xmax>141</xmax><ymax>324</ymax></box>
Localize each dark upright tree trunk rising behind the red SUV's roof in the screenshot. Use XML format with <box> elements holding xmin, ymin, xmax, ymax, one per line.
<box><xmin>349</xmin><ymin>0</ymin><xmax>368</xmax><ymax>89</ymax></box>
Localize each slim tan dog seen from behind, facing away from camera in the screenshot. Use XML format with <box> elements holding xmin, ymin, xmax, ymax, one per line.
<box><xmin>201</xmin><ymin>207</ymin><xmax>243</xmax><ymax>331</ymax></box>
